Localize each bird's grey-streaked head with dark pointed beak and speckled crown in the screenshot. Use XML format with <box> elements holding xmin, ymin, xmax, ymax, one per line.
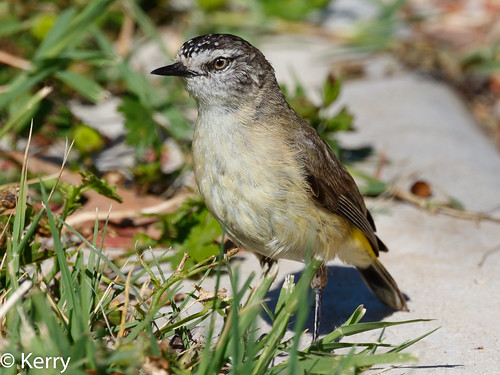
<box><xmin>151</xmin><ymin>34</ymin><xmax>281</xmax><ymax>109</ymax></box>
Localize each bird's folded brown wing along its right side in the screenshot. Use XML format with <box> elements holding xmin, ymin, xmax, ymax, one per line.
<box><xmin>292</xmin><ymin>119</ymin><xmax>380</xmax><ymax>256</ymax></box>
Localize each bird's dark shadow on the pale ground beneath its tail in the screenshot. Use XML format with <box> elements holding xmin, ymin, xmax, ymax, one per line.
<box><xmin>263</xmin><ymin>266</ymin><xmax>406</xmax><ymax>334</ymax></box>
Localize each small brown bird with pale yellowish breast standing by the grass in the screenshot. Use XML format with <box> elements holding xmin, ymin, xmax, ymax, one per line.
<box><xmin>151</xmin><ymin>34</ymin><xmax>408</xmax><ymax>341</ymax></box>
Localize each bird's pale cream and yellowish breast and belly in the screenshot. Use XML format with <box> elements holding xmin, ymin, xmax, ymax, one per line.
<box><xmin>193</xmin><ymin>106</ymin><xmax>369</xmax><ymax>263</ymax></box>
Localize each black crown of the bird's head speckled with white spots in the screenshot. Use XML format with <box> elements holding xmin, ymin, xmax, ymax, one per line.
<box><xmin>178</xmin><ymin>34</ymin><xmax>255</xmax><ymax>58</ymax></box>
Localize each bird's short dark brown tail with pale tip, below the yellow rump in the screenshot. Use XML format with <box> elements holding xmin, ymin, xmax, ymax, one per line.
<box><xmin>358</xmin><ymin>258</ymin><xmax>408</xmax><ymax>311</ymax></box>
